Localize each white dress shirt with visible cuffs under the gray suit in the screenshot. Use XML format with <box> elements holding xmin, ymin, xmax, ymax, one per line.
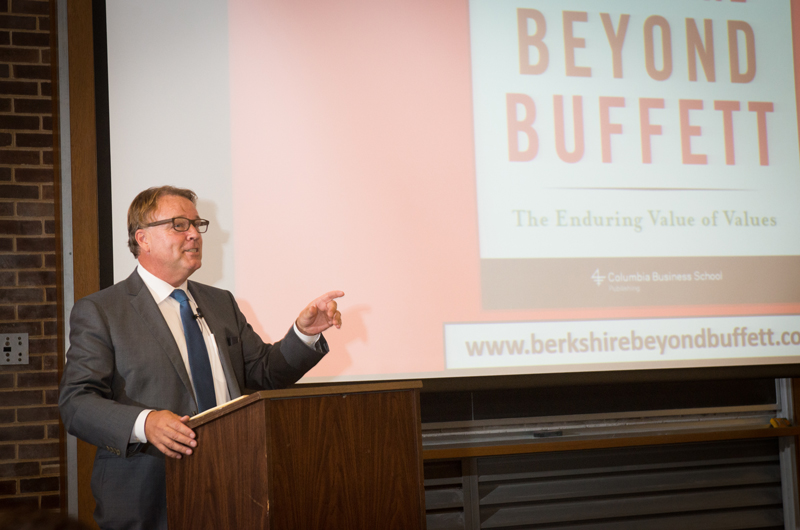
<box><xmin>130</xmin><ymin>264</ymin><xmax>319</xmax><ymax>443</ymax></box>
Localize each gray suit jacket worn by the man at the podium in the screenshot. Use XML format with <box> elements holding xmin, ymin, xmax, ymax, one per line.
<box><xmin>59</xmin><ymin>272</ymin><xmax>328</xmax><ymax>529</ymax></box>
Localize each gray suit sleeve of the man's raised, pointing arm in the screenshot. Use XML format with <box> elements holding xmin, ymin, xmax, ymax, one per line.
<box><xmin>230</xmin><ymin>288</ymin><xmax>328</xmax><ymax>390</ymax></box>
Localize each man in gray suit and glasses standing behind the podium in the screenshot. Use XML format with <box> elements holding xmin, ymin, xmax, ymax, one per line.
<box><xmin>59</xmin><ymin>186</ymin><xmax>344</xmax><ymax>530</ymax></box>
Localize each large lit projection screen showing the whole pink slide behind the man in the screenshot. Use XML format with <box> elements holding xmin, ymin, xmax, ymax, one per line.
<box><xmin>109</xmin><ymin>0</ymin><xmax>800</xmax><ymax>381</ymax></box>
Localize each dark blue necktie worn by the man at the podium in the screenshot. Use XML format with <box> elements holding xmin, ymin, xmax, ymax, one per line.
<box><xmin>170</xmin><ymin>289</ymin><xmax>217</xmax><ymax>412</ymax></box>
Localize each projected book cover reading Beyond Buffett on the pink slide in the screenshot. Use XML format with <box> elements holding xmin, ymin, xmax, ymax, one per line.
<box><xmin>470</xmin><ymin>0</ymin><xmax>800</xmax><ymax>308</ymax></box>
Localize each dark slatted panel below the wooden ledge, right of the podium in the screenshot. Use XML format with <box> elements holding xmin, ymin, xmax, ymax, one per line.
<box><xmin>426</xmin><ymin>439</ymin><xmax>784</xmax><ymax>530</ymax></box>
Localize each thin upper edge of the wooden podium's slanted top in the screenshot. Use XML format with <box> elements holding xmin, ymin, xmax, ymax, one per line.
<box><xmin>187</xmin><ymin>381</ymin><xmax>422</xmax><ymax>429</ymax></box>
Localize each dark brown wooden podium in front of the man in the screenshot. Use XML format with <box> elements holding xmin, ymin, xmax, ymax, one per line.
<box><xmin>167</xmin><ymin>382</ymin><xmax>425</xmax><ymax>530</ymax></box>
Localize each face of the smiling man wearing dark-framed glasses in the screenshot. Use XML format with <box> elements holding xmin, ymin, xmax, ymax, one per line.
<box><xmin>136</xmin><ymin>195</ymin><xmax>203</xmax><ymax>287</ymax></box>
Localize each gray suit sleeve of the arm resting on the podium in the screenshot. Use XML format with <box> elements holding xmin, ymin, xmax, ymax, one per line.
<box><xmin>58</xmin><ymin>298</ymin><xmax>144</xmax><ymax>456</ymax></box>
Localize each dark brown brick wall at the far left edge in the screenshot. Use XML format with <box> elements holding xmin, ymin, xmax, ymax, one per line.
<box><xmin>0</xmin><ymin>0</ymin><xmax>60</xmax><ymax>510</ymax></box>
